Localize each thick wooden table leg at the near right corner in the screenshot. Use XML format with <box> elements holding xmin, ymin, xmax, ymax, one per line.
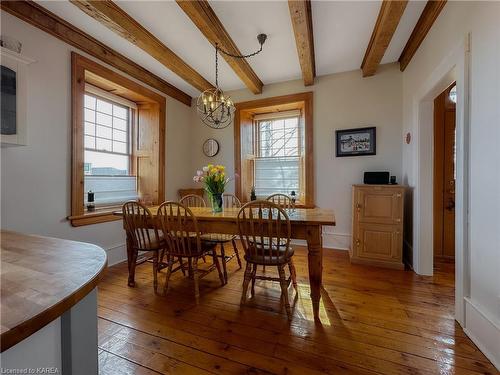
<box><xmin>306</xmin><ymin>225</ymin><xmax>323</xmax><ymax>320</ymax></box>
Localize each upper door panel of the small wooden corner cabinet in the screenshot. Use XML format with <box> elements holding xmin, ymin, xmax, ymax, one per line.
<box><xmin>355</xmin><ymin>189</ymin><xmax>403</xmax><ymax>224</ymax></box>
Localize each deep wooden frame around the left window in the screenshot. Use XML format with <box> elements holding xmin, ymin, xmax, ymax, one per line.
<box><xmin>68</xmin><ymin>52</ymin><xmax>166</xmax><ymax>226</ymax></box>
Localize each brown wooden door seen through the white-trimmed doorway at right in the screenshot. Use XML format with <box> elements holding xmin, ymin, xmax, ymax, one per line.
<box><xmin>434</xmin><ymin>84</ymin><xmax>456</xmax><ymax>258</ymax></box>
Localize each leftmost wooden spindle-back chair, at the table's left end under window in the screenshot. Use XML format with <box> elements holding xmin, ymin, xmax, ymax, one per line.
<box><xmin>122</xmin><ymin>201</ymin><xmax>166</xmax><ymax>292</ymax></box>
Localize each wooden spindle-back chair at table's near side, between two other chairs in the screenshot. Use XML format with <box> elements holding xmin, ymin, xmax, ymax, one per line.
<box><xmin>157</xmin><ymin>202</ymin><xmax>224</xmax><ymax>301</ymax></box>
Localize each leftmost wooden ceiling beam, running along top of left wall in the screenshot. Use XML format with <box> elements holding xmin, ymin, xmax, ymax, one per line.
<box><xmin>0</xmin><ymin>1</ymin><xmax>191</xmax><ymax>106</ymax></box>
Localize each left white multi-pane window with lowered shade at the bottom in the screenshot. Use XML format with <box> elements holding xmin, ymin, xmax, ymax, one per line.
<box><xmin>84</xmin><ymin>85</ymin><xmax>137</xmax><ymax>206</ymax></box>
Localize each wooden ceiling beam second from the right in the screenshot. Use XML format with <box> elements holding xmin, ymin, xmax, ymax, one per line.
<box><xmin>361</xmin><ymin>0</ymin><xmax>408</xmax><ymax>77</ymax></box>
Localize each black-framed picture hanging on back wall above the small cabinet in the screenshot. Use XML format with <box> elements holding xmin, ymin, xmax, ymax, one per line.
<box><xmin>335</xmin><ymin>126</ymin><xmax>377</xmax><ymax>157</ymax></box>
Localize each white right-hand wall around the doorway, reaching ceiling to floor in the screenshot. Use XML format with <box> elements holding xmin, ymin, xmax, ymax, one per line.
<box><xmin>403</xmin><ymin>2</ymin><xmax>500</xmax><ymax>367</ymax></box>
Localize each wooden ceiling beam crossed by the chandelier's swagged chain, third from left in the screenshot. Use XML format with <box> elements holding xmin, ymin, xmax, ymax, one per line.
<box><xmin>177</xmin><ymin>0</ymin><xmax>263</xmax><ymax>94</ymax></box>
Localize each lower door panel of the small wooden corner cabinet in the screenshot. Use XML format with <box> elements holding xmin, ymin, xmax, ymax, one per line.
<box><xmin>356</xmin><ymin>223</ymin><xmax>401</xmax><ymax>261</ymax></box>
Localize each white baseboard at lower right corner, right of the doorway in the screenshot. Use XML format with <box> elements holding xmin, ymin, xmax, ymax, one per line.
<box><xmin>464</xmin><ymin>297</ymin><xmax>500</xmax><ymax>371</ymax></box>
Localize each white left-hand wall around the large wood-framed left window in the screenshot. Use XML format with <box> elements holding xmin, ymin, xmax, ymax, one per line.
<box><xmin>1</xmin><ymin>12</ymin><xmax>191</xmax><ymax>263</ymax></box>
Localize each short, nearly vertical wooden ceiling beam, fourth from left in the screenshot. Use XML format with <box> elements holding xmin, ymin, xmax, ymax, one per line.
<box><xmin>288</xmin><ymin>0</ymin><xmax>316</xmax><ymax>86</ymax></box>
